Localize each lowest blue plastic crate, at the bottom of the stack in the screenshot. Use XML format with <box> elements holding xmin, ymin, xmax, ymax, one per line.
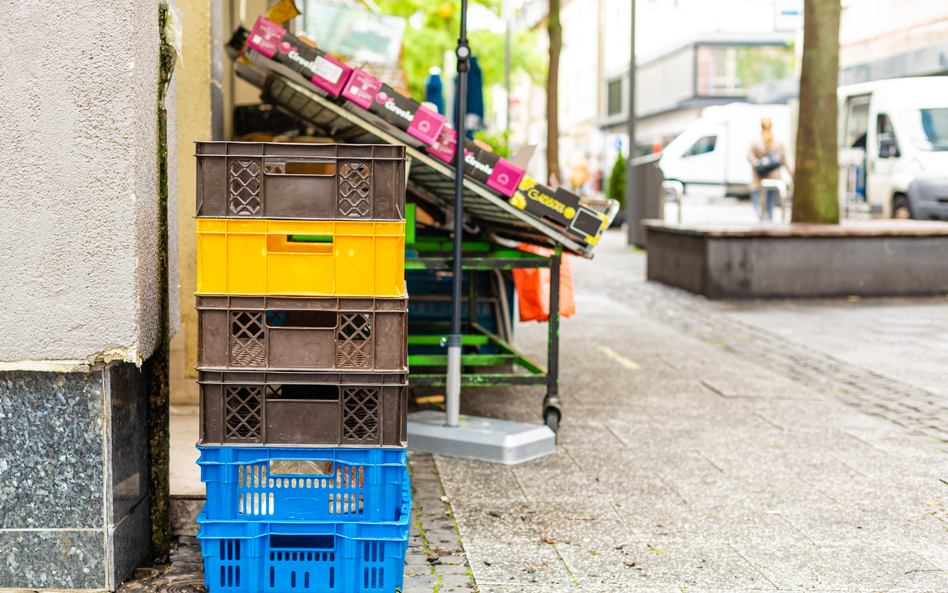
<box><xmin>198</xmin><ymin>501</ymin><xmax>411</xmax><ymax>593</ymax></box>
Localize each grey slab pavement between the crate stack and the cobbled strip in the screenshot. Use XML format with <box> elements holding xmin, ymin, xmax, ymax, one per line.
<box><xmin>435</xmin><ymin>236</ymin><xmax>948</xmax><ymax>593</ymax></box>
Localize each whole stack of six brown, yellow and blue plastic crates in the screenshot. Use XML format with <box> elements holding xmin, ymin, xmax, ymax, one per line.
<box><xmin>196</xmin><ymin>142</ymin><xmax>411</xmax><ymax>593</ymax></box>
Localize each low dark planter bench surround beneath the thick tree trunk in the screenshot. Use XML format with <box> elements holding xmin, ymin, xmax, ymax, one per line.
<box><xmin>643</xmin><ymin>220</ymin><xmax>948</xmax><ymax>299</ymax></box>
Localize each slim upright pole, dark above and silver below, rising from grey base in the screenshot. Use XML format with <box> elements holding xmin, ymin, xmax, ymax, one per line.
<box><xmin>444</xmin><ymin>0</ymin><xmax>471</xmax><ymax>426</ymax></box>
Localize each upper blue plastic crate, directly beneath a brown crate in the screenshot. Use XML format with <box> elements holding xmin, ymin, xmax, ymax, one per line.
<box><xmin>198</xmin><ymin>447</ymin><xmax>411</xmax><ymax>522</ymax></box>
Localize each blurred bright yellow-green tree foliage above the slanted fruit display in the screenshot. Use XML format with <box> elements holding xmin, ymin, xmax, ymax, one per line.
<box><xmin>377</xmin><ymin>0</ymin><xmax>545</xmax><ymax>101</ymax></box>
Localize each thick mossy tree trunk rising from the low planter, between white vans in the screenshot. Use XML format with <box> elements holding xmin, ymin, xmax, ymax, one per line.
<box><xmin>791</xmin><ymin>0</ymin><xmax>841</xmax><ymax>224</ymax></box>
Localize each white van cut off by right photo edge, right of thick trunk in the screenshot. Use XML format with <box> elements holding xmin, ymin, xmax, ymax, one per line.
<box><xmin>837</xmin><ymin>76</ymin><xmax>948</xmax><ymax>220</ymax></box>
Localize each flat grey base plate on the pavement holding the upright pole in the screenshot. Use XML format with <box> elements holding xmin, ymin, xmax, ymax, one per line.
<box><xmin>408</xmin><ymin>410</ymin><xmax>556</xmax><ymax>465</ymax></box>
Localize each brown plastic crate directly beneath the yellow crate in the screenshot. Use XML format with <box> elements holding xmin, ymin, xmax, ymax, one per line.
<box><xmin>196</xmin><ymin>295</ymin><xmax>408</xmax><ymax>373</ymax></box>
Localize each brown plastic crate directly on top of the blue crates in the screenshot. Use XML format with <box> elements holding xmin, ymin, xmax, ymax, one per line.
<box><xmin>198</xmin><ymin>371</ymin><xmax>408</xmax><ymax>448</ymax></box>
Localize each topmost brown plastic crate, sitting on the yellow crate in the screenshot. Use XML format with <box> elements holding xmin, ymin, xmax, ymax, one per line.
<box><xmin>195</xmin><ymin>142</ymin><xmax>405</xmax><ymax>221</ymax></box>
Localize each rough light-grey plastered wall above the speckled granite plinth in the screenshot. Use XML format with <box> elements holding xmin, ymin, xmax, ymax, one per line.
<box><xmin>0</xmin><ymin>0</ymin><xmax>176</xmax><ymax>369</ymax></box>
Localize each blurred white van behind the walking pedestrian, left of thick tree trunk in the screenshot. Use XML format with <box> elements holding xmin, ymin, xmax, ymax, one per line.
<box><xmin>658</xmin><ymin>103</ymin><xmax>793</xmax><ymax>196</ymax></box>
